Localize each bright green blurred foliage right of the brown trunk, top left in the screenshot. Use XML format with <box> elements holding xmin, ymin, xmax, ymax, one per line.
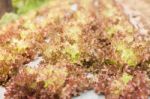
<box><xmin>12</xmin><ymin>0</ymin><xmax>48</xmax><ymax>14</ymax></box>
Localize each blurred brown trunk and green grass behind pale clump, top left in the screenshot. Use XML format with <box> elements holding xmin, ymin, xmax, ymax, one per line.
<box><xmin>0</xmin><ymin>0</ymin><xmax>49</xmax><ymax>16</ymax></box>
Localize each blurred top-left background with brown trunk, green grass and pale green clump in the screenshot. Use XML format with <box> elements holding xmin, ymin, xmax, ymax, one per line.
<box><xmin>0</xmin><ymin>0</ymin><xmax>50</xmax><ymax>27</ymax></box>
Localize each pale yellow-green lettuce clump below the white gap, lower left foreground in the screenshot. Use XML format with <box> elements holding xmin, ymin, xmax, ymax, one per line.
<box><xmin>26</xmin><ymin>65</ymin><xmax>68</xmax><ymax>88</ymax></box>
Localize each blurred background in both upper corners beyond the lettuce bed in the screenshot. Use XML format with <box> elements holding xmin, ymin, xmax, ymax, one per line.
<box><xmin>0</xmin><ymin>0</ymin><xmax>150</xmax><ymax>29</ymax></box>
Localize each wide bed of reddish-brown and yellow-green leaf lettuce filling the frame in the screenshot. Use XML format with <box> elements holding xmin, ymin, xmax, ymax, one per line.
<box><xmin>0</xmin><ymin>0</ymin><xmax>150</xmax><ymax>99</ymax></box>
